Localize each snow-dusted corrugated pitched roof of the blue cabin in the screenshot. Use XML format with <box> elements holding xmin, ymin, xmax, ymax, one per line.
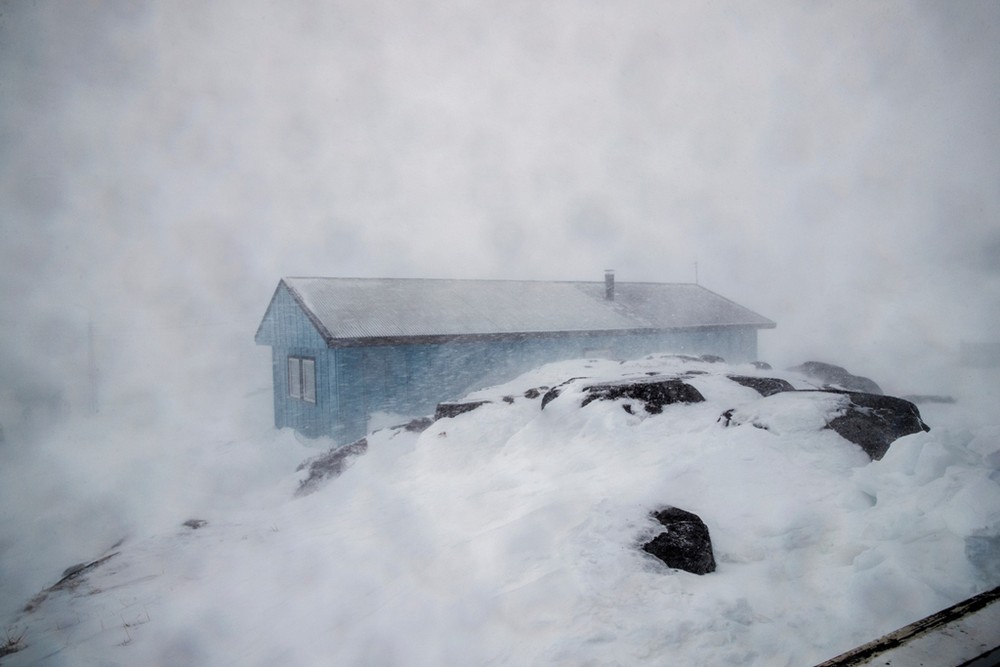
<box><xmin>264</xmin><ymin>278</ymin><xmax>775</xmax><ymax>344</ymax></box>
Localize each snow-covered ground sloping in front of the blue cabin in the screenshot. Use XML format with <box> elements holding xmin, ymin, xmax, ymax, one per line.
<box><xmin>0</xmin><ymin>358</ymin><xmax>1000</xmax><ymax>667</ymax></box>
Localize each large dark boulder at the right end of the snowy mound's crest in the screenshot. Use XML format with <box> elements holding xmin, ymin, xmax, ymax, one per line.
<box><xmin>828</xmin><ymin>392</ymin><xmax>931</xmax><ymax>461</ymax></box>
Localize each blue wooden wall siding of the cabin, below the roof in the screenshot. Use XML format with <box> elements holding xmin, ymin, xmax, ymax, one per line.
<box><xmin>255</xmin><ymin>282</ymin><xmax>757</xmax><ymax>442</ymax></box>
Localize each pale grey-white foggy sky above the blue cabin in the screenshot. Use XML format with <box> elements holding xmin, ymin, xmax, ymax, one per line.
<box><xmin>0</xmin><ymin>0</ymin><xmax>1000</xmax><ymax>410</ymax></box>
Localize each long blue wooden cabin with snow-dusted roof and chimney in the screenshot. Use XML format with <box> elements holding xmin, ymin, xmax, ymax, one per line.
<box><xmin>255</xmin><ymin>272</ymin><xmax>775</xmax><ymax>442</ymax></box>
